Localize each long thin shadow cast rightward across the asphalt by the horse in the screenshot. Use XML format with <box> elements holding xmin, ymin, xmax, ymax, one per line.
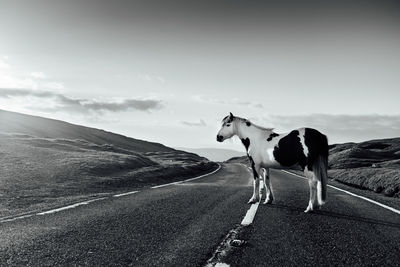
<box><xmin>265</xmin><ymin>203</ymin><xmax>400</xmax><ymax>229</ymax></box>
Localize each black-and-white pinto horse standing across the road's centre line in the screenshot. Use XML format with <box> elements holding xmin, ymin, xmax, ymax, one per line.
<box><xmin>217</xmin><ymin>113</ymin><xmax>329</xmax><ymax>213</ymax></box>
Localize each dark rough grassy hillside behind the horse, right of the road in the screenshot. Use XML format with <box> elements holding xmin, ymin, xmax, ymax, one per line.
<box><xmin>229</xmin><ymin>138</ymin><xmax>400</xmax><ymax>197</ymax></box>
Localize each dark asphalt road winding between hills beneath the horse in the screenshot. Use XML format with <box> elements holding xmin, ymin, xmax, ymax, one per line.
<box><xmin>0</xmin><ymin>164</ymin><xmax>400</xmax><ymax>266</ymax></box>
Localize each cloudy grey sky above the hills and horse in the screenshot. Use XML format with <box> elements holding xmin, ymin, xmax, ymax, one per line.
<box><xmin>0</xmin><ymin>0</ymin><xmax>400</xmax><ymax>150</ymax></box>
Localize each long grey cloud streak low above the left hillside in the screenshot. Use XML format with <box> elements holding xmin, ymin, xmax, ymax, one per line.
<box><xmin>0</xmin><ymin>88</ymin><xmax>163</xmax><ymax>112</ymax></box>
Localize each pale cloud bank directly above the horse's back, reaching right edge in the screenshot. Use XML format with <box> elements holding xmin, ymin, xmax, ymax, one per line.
<box><xmin>250</xmin><ymin>114</ymin><xmax>400</xmax><ymax>143</ymax></box>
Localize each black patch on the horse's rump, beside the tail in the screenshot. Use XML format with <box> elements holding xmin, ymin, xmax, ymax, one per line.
<box><xmin>304</xmin><ymin>128</ymin><xmax>329</xmax><ymax>170</ymax></box>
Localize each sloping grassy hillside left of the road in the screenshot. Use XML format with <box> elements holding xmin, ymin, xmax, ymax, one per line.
<box><xmin>0</xmin><ymin>111</ymin><xmax>216</xmax><ymax>217</ymax></box>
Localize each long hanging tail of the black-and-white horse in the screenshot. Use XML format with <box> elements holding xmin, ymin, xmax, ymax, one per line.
<box><xmin>313</xmin><ymin>135</ymin><xmax>329</xmax><ymax>205</ymax></box>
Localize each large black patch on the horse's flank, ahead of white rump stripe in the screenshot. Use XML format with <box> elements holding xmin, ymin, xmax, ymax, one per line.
<box><xmin>273</xmin><ymin>130</ymin><xmax>307</xmax><ymax>170</ymax></box>
